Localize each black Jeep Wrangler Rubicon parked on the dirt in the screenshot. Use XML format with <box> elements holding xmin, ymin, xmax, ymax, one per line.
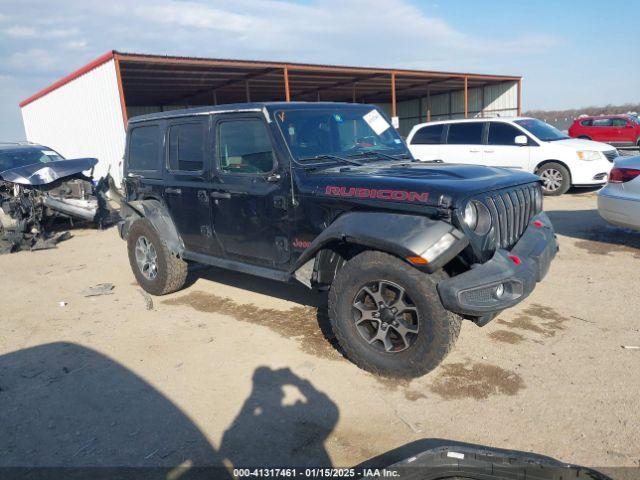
<box><xmin>119</xmin><ymin>102</ymin><xmax>557</xmax><ymax>377</ymax></box>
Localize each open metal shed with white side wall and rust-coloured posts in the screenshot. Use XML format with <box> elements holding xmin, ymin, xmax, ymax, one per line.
<box><xmin>20</xmin><ymin>51</ymin><xmax>522</xmax><ymax>182</ymax></box>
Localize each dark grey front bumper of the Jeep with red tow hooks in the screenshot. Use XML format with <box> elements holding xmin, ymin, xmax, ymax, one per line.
<box><xmin>438</xmin><ymin>213</ymin><xmax>558</xmax><ymax>318</ymax></box>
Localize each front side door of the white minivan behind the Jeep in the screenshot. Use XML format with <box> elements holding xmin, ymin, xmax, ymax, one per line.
<box><xmin>483</xmin><ymin>121</ymin><xmax>535</xmax><ymax>170</ymax></box>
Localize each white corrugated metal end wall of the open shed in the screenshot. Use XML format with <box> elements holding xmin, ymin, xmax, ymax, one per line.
<box><xmin>22</xmin><ymin>60</ymin><xmax>125</xmax><ymax>183</ymax></box>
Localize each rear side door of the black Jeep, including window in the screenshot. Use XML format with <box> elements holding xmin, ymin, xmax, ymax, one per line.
<box><xmin>163</xmin><ymin>116</ymin><xmax>221</xmax><ymax>255</ymax></box>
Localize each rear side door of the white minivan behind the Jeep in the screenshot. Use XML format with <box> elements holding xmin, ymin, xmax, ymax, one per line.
<box><xmin>440</xmin><ymin>122</ymin><xmax>486</xmax><ymax>165</ymax></box>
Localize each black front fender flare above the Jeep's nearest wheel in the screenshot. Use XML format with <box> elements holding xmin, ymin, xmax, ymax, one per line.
<box><xmin>291</xmin><ymin>212</ymin><xmax>469</xmax><ymax>282</ymax></box>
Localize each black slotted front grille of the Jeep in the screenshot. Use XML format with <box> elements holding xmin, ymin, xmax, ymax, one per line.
<box><xmin>485</xmin><ymin>184</ymin><xmax>542</xmax><ymax>249</ymax></box>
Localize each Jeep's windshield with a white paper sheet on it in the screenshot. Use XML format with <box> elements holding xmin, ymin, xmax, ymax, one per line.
<box><xmin>275</xmin><ymin>107</ymin><xmax>410</xmax><ymax>160</ymax></box>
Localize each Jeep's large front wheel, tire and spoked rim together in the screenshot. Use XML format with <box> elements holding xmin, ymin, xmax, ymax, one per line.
<box><xmin>329</xmin><ymin>251</ymin><xmax>462</xmax><ymax>378</ymax></box>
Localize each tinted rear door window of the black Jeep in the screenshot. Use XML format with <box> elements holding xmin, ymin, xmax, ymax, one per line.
<box><xmin>168</xmin><ymin>123</ymin><xmax>206</xmax><ymax>172</ymax></box>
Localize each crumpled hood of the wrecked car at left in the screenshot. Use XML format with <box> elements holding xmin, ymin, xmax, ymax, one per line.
<box><xmin>0</xmin><ymin>158</ymin><xmax>98</xmax><ymax>186</ymax></box>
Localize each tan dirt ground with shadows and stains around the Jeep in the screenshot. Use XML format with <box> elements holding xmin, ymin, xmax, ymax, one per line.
<box><xmin>0</xmin><ymin>188</ymin><xmax>640</xmax><ymax>467</ymax></box>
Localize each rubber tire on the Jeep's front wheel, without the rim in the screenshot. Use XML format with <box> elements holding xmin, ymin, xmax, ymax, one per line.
<box><xmin>329</xmin><ymin>251</ymin><xmax>462</xmax><ymax>378</ymax></box>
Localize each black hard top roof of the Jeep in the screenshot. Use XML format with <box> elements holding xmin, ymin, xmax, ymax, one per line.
<box><xmin>129</xmin><ymin>102</ymin><xmax>376</xmax><ymax>123</ymax></box>
